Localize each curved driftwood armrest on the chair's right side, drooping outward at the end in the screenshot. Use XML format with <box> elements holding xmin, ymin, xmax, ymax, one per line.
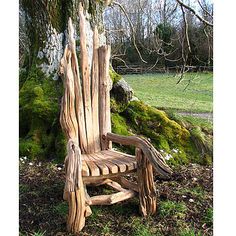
<box><xmin>103</xmin><ymin>133</ymin><xmax>172</xmax><ymax>177</ymax></box>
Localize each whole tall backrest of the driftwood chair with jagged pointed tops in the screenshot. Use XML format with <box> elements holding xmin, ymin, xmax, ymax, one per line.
<box><xmin>60</xmin><ymin>14</ymin><xmax>111</xmax><ymax>153</ymax></box>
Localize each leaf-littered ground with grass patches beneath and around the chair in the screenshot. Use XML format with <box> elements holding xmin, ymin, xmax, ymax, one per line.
<box><xmin>19</xmin><ymin>159</ymin><xmax>213</xmax><ymax>236</ymax></box>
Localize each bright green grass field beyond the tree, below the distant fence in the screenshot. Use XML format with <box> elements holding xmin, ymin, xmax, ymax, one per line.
<box><xmin>123</xmin><ymin>72</ymin><xmax>213</xmax><ymax>112</ymax></box>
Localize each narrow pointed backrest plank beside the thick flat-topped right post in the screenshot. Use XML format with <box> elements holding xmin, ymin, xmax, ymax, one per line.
<box><xmin>91</xmin><ymin>26</ymin><xmax>101</xmax><ymax>152</ymax></box>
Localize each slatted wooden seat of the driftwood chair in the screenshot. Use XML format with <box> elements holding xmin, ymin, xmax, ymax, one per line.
<box><xmin>82</xmin><ymin>149</ymin><xmax>137</xmax><ymax>176</ymax></box>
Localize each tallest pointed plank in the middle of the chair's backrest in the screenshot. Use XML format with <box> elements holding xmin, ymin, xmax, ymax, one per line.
<box><xmin>79</xmin><ymin>4</ymin><xmax>94</xmax><ymax>153</ymax></box>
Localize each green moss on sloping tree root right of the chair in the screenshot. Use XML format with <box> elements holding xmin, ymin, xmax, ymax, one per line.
<box><xmin>122</xmin><ymin>101</ymin><xmax>197</xmax><ymax>164</ymax></box>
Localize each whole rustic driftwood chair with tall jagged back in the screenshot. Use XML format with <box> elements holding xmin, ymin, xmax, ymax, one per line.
<box><xmin>60</xmin><ymin>5</ymin><xmax>171</xmax><ymax>233</ymax></box>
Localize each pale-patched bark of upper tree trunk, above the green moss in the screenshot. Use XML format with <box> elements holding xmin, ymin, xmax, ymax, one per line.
<box><xmin>19</xmin><ymin>0</ymin><xmax>105</xmax><ymax>79</ymax></box>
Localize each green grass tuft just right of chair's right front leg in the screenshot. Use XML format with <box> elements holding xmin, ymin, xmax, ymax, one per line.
<box><xmin>159</xmin><ymin>200</ymin><xmax>187</xmax><ymax>219</ymax></box>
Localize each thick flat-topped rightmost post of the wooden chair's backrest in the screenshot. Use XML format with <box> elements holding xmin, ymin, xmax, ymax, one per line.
<box><xmin>98</xmin><ymin>46</ymin><xmax>111</xmax><ymax>150</ymax></box>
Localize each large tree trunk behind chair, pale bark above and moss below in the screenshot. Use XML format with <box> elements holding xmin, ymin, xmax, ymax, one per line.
<box><xmin>19</xmin><ymin>0</ymin><xmax>106</xmax><ymax>160</ymax></box>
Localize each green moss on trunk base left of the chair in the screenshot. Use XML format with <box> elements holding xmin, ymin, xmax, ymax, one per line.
<box><xmin>19</xmin><ymin>67</ymin><xmax>65</xmax><ymax>159</ymax></box>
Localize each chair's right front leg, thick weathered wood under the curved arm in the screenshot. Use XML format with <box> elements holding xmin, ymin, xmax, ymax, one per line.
<box><xmin>136</xmin><ymin>148</ymin><xmax>157</xmax><ymax>216</ymax></box>
